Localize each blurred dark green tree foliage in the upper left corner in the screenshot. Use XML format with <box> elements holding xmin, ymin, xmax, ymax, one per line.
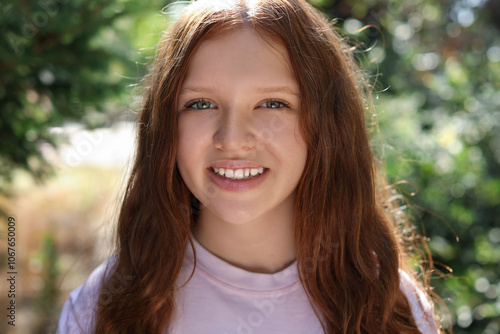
<box><xmin>0</xmin><ymin>0</ymin><xmax>164</xmax><ymax>192</ymax></box>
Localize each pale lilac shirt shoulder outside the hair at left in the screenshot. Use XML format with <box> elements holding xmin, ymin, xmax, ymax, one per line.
<box><xmin>57</xmin><ymin>257</ymin><xmax>115</xmax><ymax>334</ymax></box>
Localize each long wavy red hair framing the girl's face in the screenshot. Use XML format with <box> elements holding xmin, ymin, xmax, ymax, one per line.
<box><xmin>95</xmin><ymin>0</ymin><xmax>440</xmax><ymax>334</ymax></box>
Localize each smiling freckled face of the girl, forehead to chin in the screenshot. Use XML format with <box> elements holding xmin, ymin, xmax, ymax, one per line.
<box><xmin>177</xmin><ymin>28</ymin><xmax>307</xmax><ymax>224</ymax></box>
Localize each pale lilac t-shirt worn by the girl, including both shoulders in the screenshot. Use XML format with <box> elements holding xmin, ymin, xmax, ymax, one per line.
<box><xmin>57</xmin><ymin>240</ymin><xmax>437</xmax><ymax>334</ymax></box>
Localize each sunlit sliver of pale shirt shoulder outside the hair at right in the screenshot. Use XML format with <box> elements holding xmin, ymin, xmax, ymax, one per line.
<box><xmin>399</xmin><ymin>269</ymin><xmax>439</xmax><ymax>334</ymax></box>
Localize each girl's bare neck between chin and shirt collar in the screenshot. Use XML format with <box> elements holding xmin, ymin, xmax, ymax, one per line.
<box><xmin>194</xmin><ymin>200</ymin><xmax>295</xmax><ymax>273</ymax></box>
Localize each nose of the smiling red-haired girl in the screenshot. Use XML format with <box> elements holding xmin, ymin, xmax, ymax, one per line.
<box><xmin>213</xmin><ymin>110</ymin><xmax>256</xmax><ymax>152</ymax></box>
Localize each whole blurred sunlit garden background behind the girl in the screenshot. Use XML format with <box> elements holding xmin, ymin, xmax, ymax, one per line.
<box><xmin>0</xmin><ymin>0</ymin><xmax>500</xmax><ymax>334</ymax></box>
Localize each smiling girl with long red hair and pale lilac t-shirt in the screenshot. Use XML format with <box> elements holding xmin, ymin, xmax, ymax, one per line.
<box><xmin>58</xmin><ymin>0</ymin><xmax>444</xmax><ymax>334</ymax></box>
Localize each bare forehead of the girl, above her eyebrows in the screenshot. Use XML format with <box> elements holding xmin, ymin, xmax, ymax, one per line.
<box><xmin>184</xmin><ymin>28</ymin><xmax>296</xmax><ymax>90</ymax></box>
